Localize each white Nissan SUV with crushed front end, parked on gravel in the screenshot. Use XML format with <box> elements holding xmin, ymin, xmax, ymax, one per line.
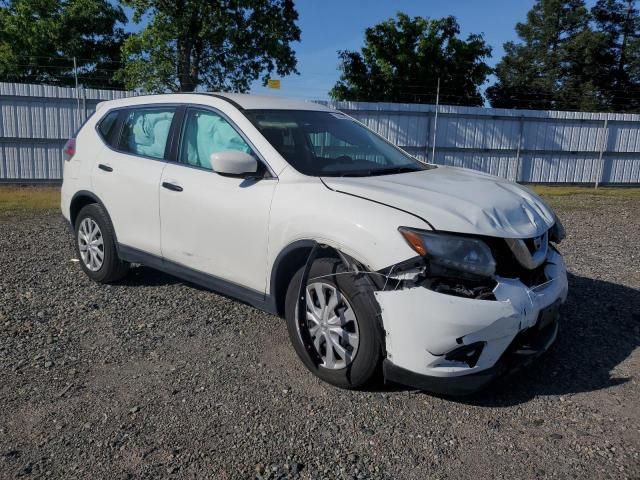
<box><xmin>62</xmin><ymin>94</ymin><xmax>567</xmax><ymax>394</ymax></box>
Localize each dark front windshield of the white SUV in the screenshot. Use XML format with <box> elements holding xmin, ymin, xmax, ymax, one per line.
<box><xmin>246</xmin><ymin>110</ymin><xmax>434</xmax><ymax>177</ymax></box>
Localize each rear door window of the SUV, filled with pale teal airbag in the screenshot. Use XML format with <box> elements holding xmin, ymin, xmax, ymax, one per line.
<box><xmin>119</xmin><ymin>107</ymin><xmax>176</xmax><ymax>158</ymax></box>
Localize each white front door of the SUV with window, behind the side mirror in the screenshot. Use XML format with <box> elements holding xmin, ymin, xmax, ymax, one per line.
<box><xmin>160</xmin><ymin>107</ymin><xmax>277</xmax><ymax>294</ymax></box>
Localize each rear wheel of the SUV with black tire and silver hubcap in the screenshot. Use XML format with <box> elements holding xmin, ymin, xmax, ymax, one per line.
<box><xmin>75</xmin><ymin>203</ymin><xmax>129</xmax><ymax>283</ymax></box>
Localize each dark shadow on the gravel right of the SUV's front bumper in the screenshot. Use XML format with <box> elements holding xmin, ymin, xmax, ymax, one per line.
<box><xmin>452</xmin><ymin>274</ymin><xmax>640</xmax><ymax>407</ymax></box>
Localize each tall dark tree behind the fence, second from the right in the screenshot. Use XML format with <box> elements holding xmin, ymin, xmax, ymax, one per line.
<box><xmin>487</xmin><ymin>0</ymin><xmax>601</xmax><ymax>109</ymax></box>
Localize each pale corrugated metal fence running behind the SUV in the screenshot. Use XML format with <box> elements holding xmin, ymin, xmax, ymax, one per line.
<box><xmin>0</xmin><ymin>83</ymin><xmax>640</xmax><ymax>184</ymax></box>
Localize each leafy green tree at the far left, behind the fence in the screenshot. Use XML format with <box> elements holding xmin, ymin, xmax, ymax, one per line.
<box><xmin>0</xmin><ymin>0</ymin><xmax>127</xmax><ymax>88</ymax></box>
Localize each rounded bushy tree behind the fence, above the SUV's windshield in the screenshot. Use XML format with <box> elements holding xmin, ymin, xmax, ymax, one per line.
<box><xmin>329</xmin><ymin>13</ymin><xmax>491</xmax><ymax>105</ymax></box>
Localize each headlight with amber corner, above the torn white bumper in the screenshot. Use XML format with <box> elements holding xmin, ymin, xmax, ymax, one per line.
<box><xmin>398</xmin><ymin>227</ymin><xmax>496</xmax><ymax>277</ymax></box>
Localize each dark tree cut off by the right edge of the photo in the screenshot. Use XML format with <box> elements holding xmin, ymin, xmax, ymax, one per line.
<box><xmin>591</xmin><ymin>0</ymin><xmax>640</xmax><ymax>111</ymax></box>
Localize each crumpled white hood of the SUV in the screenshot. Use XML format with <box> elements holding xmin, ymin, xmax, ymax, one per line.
<box><xmin>322</xmin><ymin>166</ymin><xmax>555</xmax><ymax>238</ymax></box>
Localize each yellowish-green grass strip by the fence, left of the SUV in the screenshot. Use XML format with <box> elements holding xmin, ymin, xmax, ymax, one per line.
<box><xmin>0</xmin><ymin>185</ymin><xmax>60</xmax><ymax>214</ymax></box>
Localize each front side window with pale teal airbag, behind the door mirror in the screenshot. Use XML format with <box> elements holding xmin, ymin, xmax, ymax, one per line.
<box><xmin>180</xmin><ymin>109</ymin><xmax>252</xmax><ymax>169</ymax></box>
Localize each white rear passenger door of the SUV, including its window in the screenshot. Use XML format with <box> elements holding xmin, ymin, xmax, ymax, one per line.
<box><xmin>92</xmin><ymin>105</ymin><xmax>176</xmax><ymax>256</ymax></box>
